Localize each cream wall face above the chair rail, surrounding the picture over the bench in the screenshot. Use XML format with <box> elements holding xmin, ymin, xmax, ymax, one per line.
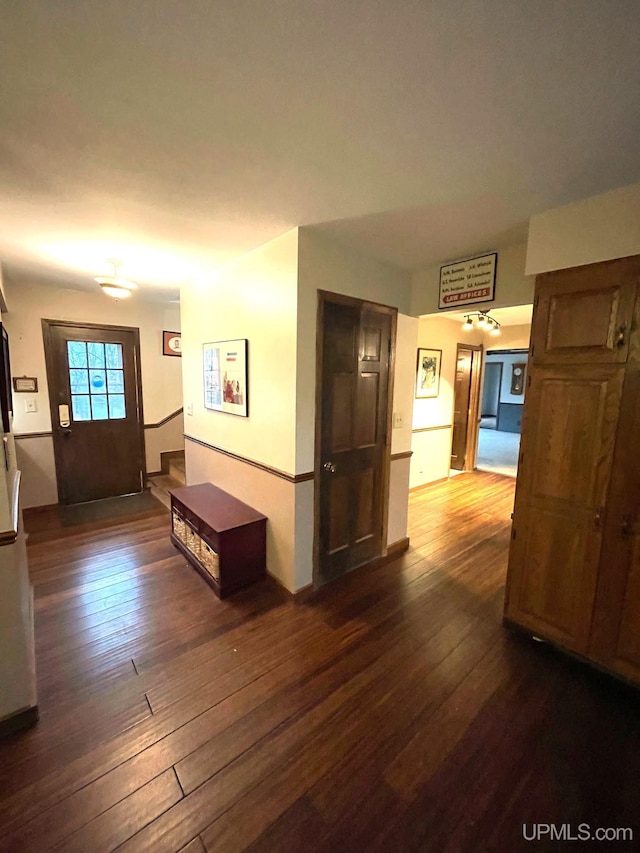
<box><xmin>181</xmin><ymin>229</ymin><xmax>298</xmax><ymax>474</ymax></box>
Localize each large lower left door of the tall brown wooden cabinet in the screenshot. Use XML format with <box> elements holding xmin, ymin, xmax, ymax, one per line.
<box><xmin>505</xmin><ymin>365</ymin><xmax>624</xmax><ymax>653</ymax></box>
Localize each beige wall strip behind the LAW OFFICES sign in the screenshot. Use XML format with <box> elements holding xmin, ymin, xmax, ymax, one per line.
<box><xmin>409</xmin><ymin>243</ymin><xmax>535</xmax><ymax>317</ymax></box>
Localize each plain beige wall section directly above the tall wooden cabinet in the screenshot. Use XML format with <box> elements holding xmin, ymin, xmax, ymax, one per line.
<box><xmin>526</xmin><ymin>183</ymin><xmax>640</xmax><ymax>275</ymax></box>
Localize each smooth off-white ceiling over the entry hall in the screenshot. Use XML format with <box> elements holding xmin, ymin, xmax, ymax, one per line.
<box><xmin>0</xmin><ymin>0</ymin><xmax>640</xmax><ymax>298</ymax></box>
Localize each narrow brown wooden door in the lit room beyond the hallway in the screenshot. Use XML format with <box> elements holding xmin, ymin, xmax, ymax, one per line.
<box><xmin>451</xmin><ymin>344</ymin><xmax>482</xmax><ymax>471</ymax></box>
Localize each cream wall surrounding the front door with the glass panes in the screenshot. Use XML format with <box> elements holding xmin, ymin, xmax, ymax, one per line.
<box><xmin>4</xmin><ymin>281</ymin><xmax>183</xmax><ymax>507</ymax></box>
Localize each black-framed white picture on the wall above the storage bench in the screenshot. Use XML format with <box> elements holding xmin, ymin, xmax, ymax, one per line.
<box><xmin>203</xmin><ymin>338</ymin><xmax>249</xmax><ymax>418</ymax></box>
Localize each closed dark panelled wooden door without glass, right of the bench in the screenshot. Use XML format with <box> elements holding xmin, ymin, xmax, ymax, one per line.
<box><xmin>316</xmin><ymin>294</ymin><xmax>396</xmax><ymax>583</ymax></box>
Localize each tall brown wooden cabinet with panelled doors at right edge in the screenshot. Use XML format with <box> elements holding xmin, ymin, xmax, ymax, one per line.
<box><xmin>505</xmin><ymin>257</ymin><xmax>640</xmax><ymax>683</ymax></box>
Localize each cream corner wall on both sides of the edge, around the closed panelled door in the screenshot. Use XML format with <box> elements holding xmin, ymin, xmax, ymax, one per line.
<box><xmin>181</xmin><ymin>229</ymin><xmax>418</xmax><ymax>591</ymax></box>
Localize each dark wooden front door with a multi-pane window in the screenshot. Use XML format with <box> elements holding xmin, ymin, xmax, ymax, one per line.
<box><xmin>42</xmin><ymin>320</ymin><xmax>144</xmax><ymax>504</ymax></box>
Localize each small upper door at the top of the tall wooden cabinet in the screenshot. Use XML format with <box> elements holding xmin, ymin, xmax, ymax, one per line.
<box><xmin>532</xmin><ymin>258</ymin><xmax>640</xmax><ymax>364</ymax></box>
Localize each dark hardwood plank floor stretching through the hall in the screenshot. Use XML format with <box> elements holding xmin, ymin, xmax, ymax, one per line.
<box><xmin>0</xmin><ymin>474</ymin><xmax>640</xmax><ymax>853</ymax></box>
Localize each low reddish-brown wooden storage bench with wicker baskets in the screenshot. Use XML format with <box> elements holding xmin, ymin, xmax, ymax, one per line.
<box><xmin>169</xmin><ymin>483</ymin><xmax>267</xmax><ymax>598</ymax></box>
